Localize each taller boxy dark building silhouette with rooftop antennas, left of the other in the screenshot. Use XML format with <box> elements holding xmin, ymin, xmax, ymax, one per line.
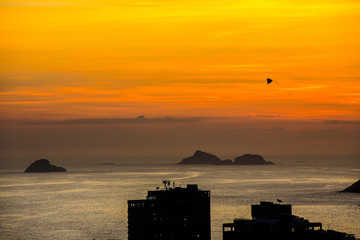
<box><xmin>128</xmin><ymin>183</ymin><xmax>211</xmax><ymax>240</ymax></box>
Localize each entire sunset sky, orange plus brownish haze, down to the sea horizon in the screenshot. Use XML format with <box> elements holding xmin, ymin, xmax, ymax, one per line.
<box><xmin>0</xmin><ymin>0</ymin><xmax>360</xmax><ymax>164</ymax></box>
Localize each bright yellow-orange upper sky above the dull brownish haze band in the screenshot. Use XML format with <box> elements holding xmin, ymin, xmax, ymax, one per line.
<box><xmin>0</xmin><ymin>0</ymin><xmax>360</xmax><ymax>120</ymax></box>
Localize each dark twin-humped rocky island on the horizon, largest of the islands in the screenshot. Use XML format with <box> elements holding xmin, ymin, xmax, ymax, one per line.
<box><xmin>177</xmin><ymin>150</ymin><xmax>274</xmax><ymax>165</ymax></box>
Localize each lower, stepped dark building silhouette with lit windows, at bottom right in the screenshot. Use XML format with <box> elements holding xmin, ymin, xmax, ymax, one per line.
<box><xmin>223</xmin><ymin>202</ymin><xmax>355</xmax><ymax>240</ymax></box>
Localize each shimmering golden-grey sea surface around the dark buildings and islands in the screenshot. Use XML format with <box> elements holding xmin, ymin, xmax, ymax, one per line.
<box><xmin>0</xmin><ymin>157</ymin><xmax>360</xmax><ymax>240</ymax></box>
